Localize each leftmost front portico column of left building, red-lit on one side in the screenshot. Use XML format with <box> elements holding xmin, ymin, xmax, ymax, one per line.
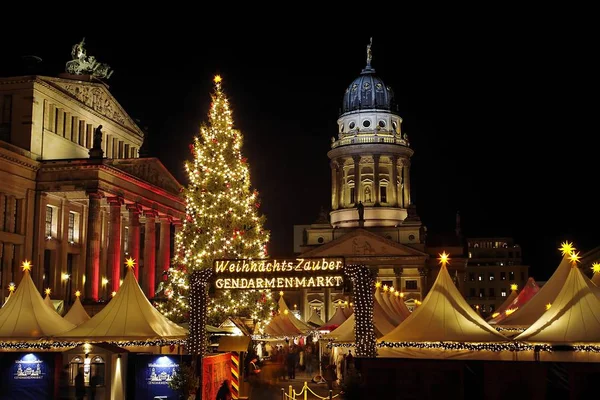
<box><xmin>85</xmin><ymin>192</ymin><xmax>102</xmax><ymax>301</ymax></box>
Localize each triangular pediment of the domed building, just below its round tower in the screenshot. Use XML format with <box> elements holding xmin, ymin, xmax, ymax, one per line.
<box><xmin>302</xmin><ymin>229</ymin><xmax>429</xmax><ymax>260</ymax></box>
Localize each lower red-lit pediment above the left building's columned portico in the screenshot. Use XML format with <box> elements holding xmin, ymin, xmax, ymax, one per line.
<box><xmin>106</xmin><ymin>158</ymin><xmax>182</xmax><ymax>195</ymax></box>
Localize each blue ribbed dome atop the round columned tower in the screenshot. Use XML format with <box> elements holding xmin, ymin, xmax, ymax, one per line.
<box><xmin>342</xmin><ymin>65</ymin><xmax>395</xmax><ymax>114</ymax></box>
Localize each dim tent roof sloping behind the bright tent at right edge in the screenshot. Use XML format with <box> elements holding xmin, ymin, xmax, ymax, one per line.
<box><xmin>498</xmin><ymin>253</ymin><xmax>571</xmax><ymax>326</ymax></box>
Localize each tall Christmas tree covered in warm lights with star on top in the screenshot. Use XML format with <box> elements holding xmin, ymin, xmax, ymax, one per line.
<box><xmin>157</xmin><ymin>76</ymin><xmax>275</xmax><ymax>324</ymax></box>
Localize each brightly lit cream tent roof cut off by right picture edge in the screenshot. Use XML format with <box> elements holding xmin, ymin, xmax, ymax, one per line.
<box><xmin>516</xmin><ymin>267</ymin><xmax>600</xmax><ymax>343</ymax></box>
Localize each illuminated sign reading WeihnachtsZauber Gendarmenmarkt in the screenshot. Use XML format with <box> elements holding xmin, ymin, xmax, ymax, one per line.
<box><xmin>214</xmin><ymin>257</ymin><xmax>344</xmax><ymax>289</ymax></box>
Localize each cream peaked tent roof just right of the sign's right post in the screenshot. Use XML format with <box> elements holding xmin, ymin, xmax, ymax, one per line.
<box><xmin>379</xmin><ymin>265</ymin><xmax>507</xmax><ymax>342</ymax></box>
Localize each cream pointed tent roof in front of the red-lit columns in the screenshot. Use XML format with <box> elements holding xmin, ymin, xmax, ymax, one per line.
<box><xmin>57</xmin><ymin>268</ymin><xmax>187</xmax><ymax>340</ymax></box>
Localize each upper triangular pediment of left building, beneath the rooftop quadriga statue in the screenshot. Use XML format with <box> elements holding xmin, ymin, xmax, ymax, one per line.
<box><xmin>38</xmin><ymin>76</ymin><xmax>144</xmax><ymax>137</ymax></box>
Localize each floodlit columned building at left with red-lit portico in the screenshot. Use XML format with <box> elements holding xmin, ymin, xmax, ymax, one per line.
<box><xmin>0</xmin><ymin>75</ymin><xmax>185</xmax><ymax>302</ymax></box>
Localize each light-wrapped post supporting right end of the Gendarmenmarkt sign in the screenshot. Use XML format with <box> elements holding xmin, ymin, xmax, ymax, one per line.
<box><xmin>345</xmin><ymin>265</ymin><xmax>377</xmax><ymax>357</ymax></box>
